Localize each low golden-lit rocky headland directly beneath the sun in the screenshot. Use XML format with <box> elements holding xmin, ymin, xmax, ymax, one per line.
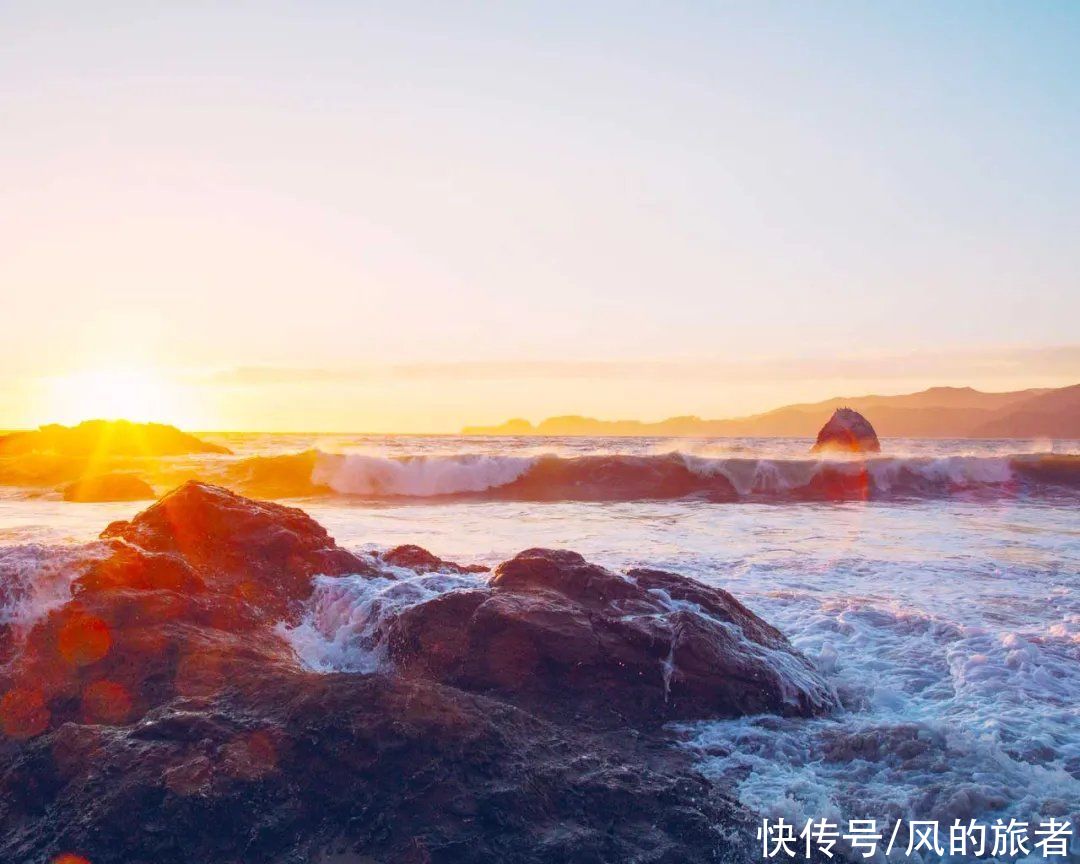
<box><xmin>0</xmin><ymin>420</ymin><xmax>229</xmax><ymax>460</ymax></box>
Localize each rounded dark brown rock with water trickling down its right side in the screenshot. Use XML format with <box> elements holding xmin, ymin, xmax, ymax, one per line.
<box><xmin>387</xmin><ymin>549</ymin><xmax>836</xmax><ymax>727</ymax></box>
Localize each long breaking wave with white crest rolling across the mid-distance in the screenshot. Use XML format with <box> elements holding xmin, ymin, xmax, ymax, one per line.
<box><xmin>231</xmin><ymin>450</ymin><xmax>1080</xmax><ymax>501</ymax></box>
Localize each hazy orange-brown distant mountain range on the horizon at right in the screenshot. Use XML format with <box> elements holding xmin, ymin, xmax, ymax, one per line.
<box><xmin>462</xmin><ymin>384</ymin><xmax>1080</xmax><ymax>438</ymax></box>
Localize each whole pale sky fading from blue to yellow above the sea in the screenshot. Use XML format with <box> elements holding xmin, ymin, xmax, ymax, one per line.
<box><xmin>0</xmin><ymin>0</ymin><xmax>1080</xmax><ymax>432</ymax></box>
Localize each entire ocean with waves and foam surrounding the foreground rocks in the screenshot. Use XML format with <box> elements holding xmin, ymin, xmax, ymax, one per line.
<box><xmin>0</xmin><ymin>434</ymin><xmax>1080</xmax><ymax>842</ymax></box>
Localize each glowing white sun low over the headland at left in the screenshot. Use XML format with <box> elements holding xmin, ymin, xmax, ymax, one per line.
<box><xmin>49</xmin><ymin>367</ymin><xmax>195</xmax><ymax>426</ymax></box>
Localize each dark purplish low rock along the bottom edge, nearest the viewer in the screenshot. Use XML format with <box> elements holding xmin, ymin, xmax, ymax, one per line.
<box><xmin>0</xmin><ymin>663</ymin><xmax>758</xmax><ymax>864</ymax></box>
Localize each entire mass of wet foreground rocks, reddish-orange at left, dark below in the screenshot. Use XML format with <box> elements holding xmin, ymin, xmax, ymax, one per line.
<box><xmin>0</xmin><ymin>483</ymin><xmax>831</xmax><ymax>864</ymax></box>
